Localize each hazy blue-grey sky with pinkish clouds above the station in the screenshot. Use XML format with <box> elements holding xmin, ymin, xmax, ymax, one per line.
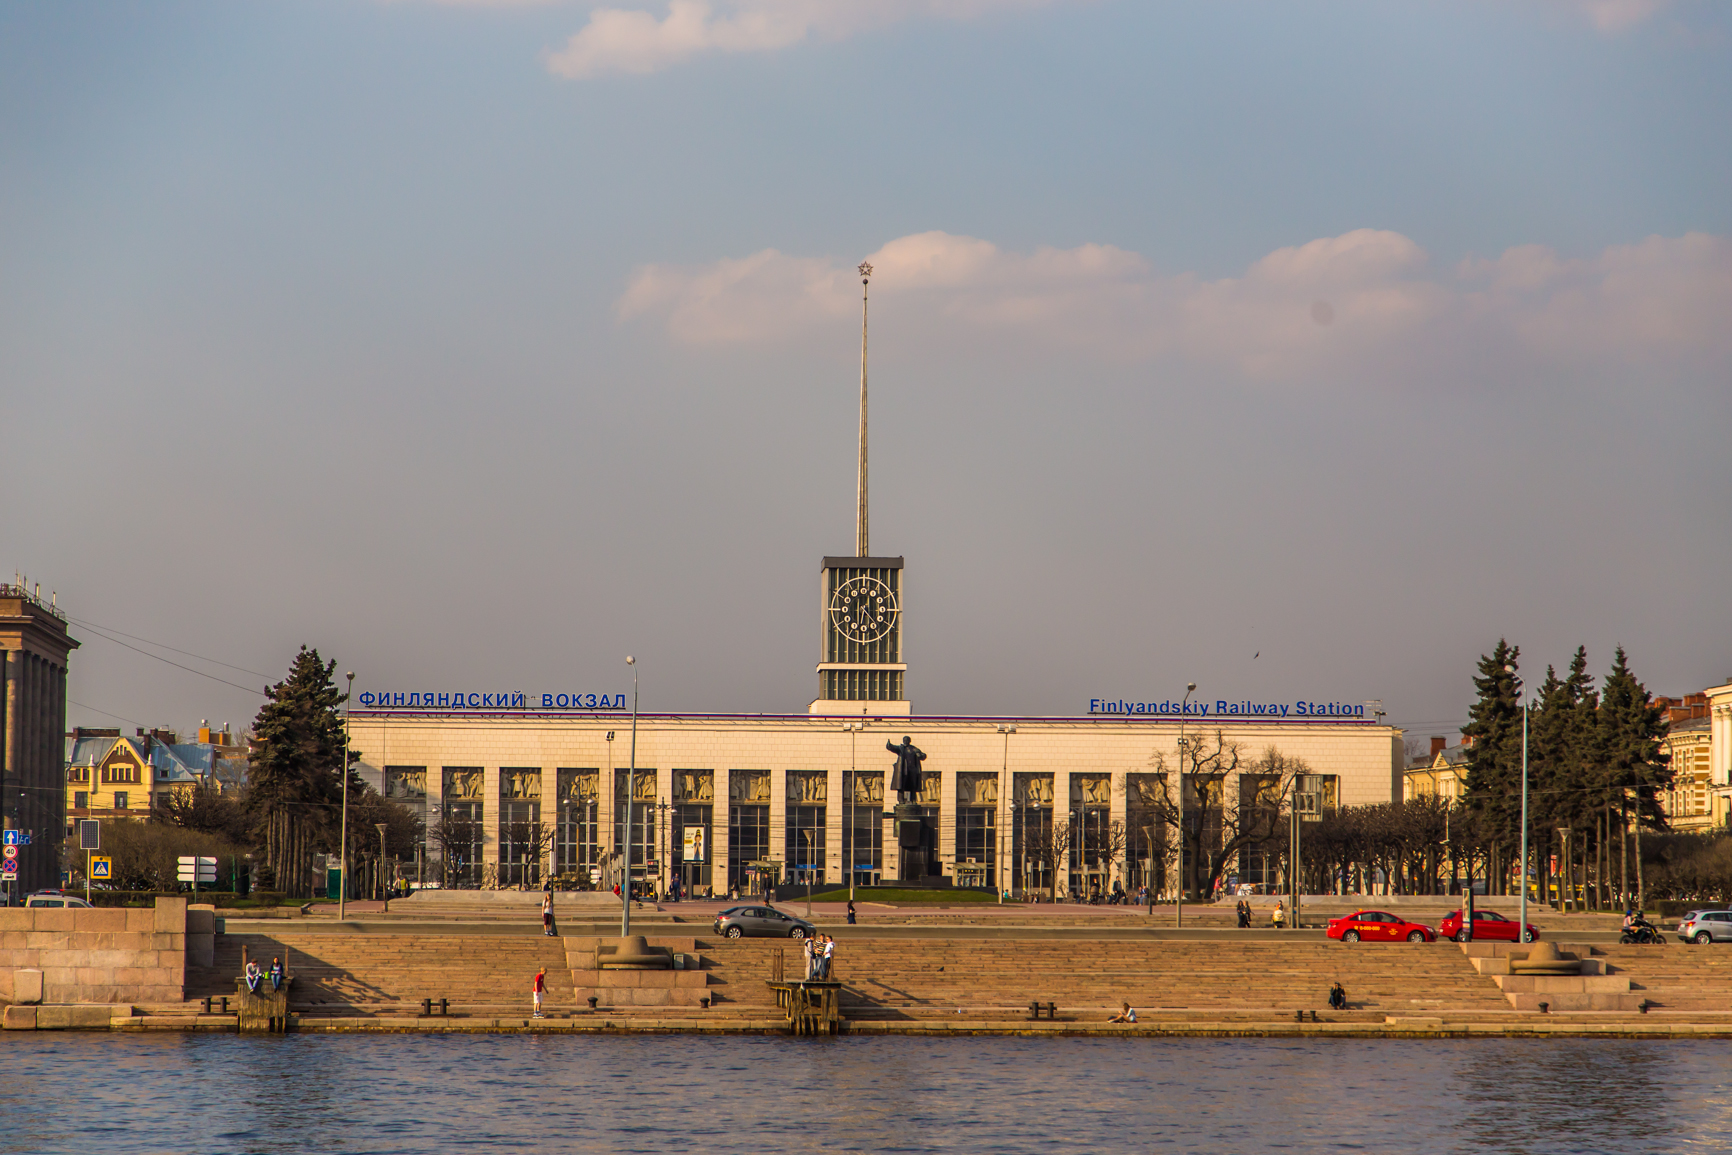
<box><xmin>0</xmin><ymin>0</ymin><xmax>1732</xmax><ymax>736</ymax></box>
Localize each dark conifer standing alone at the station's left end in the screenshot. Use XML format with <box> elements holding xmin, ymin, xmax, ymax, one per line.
<box><xmin>246</xmin><ymin>646</ymin><xmax>362</xmax><ymax>897</ymax></box>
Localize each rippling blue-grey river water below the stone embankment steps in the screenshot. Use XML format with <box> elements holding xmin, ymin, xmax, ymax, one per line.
<box><xmin>0</xmin><ymin>1032</ymin><xmax>1732</xmax><ymax>1155</ymax></box>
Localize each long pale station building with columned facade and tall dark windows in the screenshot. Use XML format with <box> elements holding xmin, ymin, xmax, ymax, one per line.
<box><xmin>350</xmin><ymin>706</ymin><xmax>1401</xmax><ymax>895</ymax></box>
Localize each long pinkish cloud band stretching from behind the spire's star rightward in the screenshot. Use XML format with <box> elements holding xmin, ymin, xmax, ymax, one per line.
<box><xmin>617</xmin><ymin>229</ymin><xmax>1732</xmax><ymax>379</ymax></box>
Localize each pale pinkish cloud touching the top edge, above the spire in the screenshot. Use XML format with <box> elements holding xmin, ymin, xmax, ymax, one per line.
<box><xmin>546</xmin><ymin>0</ymin><xmax>1058</xmax><ymax>80</ymax></box>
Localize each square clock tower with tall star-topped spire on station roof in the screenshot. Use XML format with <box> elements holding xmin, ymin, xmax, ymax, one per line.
<box><xmin>811</xmin><ymin>265</ymin><xmax>913</xmax><ymax>713</ymax></box>
